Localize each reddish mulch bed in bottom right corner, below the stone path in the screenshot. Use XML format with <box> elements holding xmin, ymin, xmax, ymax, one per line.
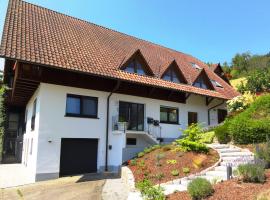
<box><xmin>167</xmin><ymin>170</ymin><xmax>270</xmax><ymax>200</ymax></box>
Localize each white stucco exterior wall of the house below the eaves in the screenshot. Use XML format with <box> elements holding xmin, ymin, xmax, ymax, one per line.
<box><xmin>23</xmin><ymin>83</ymin><xmax>227</xmax><ymax>180</ymax></box>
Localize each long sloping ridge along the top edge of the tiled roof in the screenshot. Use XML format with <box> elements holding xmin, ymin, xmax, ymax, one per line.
<box><xmin>22</xmin><ymin>0</ymin><xmax>200</xmax><ymax>63</ymax></box>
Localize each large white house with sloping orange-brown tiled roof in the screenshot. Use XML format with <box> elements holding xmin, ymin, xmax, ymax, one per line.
<box><xmin>0</xmin><ymin>0</ymin><xmax>238</xmax><ymax>181</ymax></box>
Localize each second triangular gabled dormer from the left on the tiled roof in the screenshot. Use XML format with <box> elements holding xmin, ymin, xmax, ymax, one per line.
<box><xmin>161</xmin><ymin>60</ymin><xmax>187</xmax><ymax>83</ymax></box>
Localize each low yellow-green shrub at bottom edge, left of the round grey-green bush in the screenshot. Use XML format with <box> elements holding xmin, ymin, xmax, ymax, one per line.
<box><xmin>136</xmin><ymin>179</ymin><xmax>165</xmax><ymax>200</ymax></box>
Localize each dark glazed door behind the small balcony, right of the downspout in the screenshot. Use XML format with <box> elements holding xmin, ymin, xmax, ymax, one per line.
<box><xmin>118</xmin><ymin>101</ymin><xmax>144</xmax><ymax>131</ymax></box>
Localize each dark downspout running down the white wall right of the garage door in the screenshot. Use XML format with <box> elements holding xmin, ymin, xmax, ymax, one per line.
<box><xmin>105</xmin><ymin>81</ymin><xmax>121</xmax><ymax>171</ymax></box>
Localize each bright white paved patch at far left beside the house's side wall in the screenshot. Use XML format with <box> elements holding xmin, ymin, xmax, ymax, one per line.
<box><xmin>0</xmin><ymin>164</ymin><xmax>35</xmax><ymax>188</ymax></box>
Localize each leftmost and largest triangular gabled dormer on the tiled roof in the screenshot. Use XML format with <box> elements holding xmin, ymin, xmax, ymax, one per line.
<box><xmin>120</xmin><ymin>50</ymin><xmax>154</xmax><ymax>76</ymax></box>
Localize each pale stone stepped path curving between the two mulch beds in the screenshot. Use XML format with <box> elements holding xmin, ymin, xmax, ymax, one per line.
<box><xmin>128</xmin><ymin>144</ymin><xmax>254</xmax><ymax>200</ymax></box>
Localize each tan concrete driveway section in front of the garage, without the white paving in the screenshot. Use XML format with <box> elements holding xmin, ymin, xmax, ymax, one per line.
<box><xmin>0</xmin><ymin>176</ymin><xmax>105</xmax><ymax>200</ymax></box>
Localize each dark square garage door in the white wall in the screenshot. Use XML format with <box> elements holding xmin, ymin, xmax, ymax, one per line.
<box><xmin>60</xmin><ymin>138</ymin><xmax>98</xmax><ymax>176</ymax></box>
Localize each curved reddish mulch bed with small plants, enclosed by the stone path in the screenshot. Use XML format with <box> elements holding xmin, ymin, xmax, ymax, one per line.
<box><xmin>128</xmin><ymin>145</ymin><xmax>219</xmax><ymax>184</ymax></box>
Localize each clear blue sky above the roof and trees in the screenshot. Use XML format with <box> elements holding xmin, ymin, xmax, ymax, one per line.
<box><xmin>0</xmin><ymin>0</ymin><xmax>270</xmax><ymax>69</ymax></box>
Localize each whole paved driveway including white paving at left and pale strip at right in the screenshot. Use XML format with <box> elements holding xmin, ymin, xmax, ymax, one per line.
<box><xmin>0</xmin><ymin>165</ymin><xmax>127</xmax><ymax>200</ymax></box>
